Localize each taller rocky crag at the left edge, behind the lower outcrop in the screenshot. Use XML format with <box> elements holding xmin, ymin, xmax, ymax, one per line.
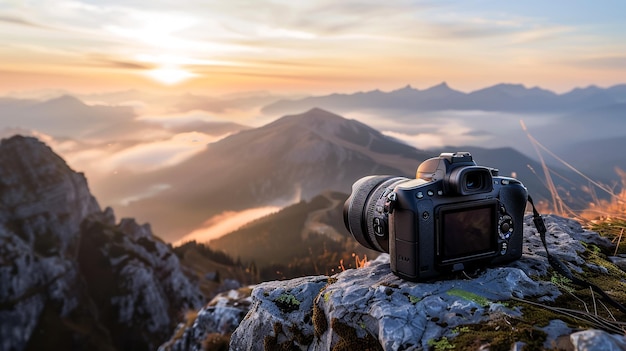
<box><xmin>0</xmin><ymin>136</ymin><xmax>100</xmax><ymax>350</ymax></box>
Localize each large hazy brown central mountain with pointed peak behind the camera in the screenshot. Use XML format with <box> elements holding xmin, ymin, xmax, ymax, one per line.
<box><xmin>123</xmin><ymin>109</ymin><xmax>431</xmax><ymax>241</ymax></box>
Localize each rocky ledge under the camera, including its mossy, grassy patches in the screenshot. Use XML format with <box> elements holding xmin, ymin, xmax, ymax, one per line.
<box><xmin>161</xmin><ymin>216</ymin><xmax>626</xmax><ymax>350</ymax></box>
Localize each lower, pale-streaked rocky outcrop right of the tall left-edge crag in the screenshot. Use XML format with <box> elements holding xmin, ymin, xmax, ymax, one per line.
<box><xmin>77</xmin><ymin>209</ymin><xmax>203</xmax><ymax>350</ymax></box>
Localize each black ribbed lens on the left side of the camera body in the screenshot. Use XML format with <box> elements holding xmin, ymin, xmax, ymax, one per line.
<box><xmin>343</xmin><ymin>176</ymin><xmax>408</xmax><ymax>252</ymax></box>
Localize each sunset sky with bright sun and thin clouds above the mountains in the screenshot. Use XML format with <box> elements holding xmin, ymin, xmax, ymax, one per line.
<box><xmin>0</xmin><ymin>0</ymin><xmax>626</xmax><ymax>94</ymax></box>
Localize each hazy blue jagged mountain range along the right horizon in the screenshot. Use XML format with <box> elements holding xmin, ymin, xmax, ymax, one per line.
<box><xmin>262</xmin><ymin>83</ymin><xmax>626</xmax><ymax>115</ymax></box>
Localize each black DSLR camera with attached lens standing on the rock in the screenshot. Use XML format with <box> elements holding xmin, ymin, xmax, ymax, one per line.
<box><xmin>343</xmin><ymin>152</ymin><xmax>528</xmax><ymax>281</ymax></box>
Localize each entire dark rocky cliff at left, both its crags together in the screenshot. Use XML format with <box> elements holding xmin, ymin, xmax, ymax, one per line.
<box><xmin>0</xmin><ymin>136</ymin><xmax>202</xmax><ymax>350</ymax></box>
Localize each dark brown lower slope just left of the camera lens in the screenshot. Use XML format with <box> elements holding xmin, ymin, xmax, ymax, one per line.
<box><xmin>210</xmin><ymin>192</ymin><xmax>378</xmax><ymax>280</ymax></box>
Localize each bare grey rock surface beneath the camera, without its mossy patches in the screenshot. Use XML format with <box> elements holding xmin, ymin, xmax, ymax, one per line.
<box><xmin>162</xmin><ymin>216</ymin><xmax>624</xmax><ymax>350</ymax></box>
